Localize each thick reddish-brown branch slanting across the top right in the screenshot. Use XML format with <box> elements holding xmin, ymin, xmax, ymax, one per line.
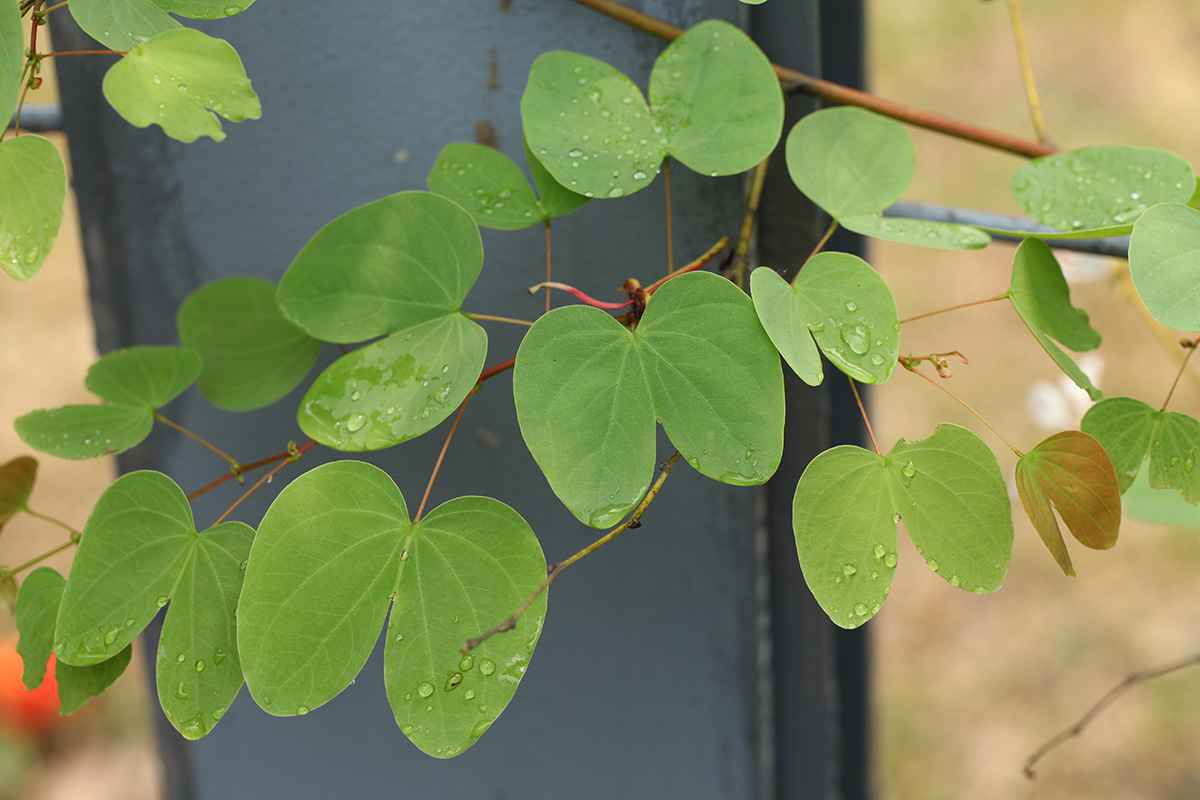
<box><xmin>575</xmin><ymin>0</ymin><xmax>1058</xmax><ymax>158</ymax></box>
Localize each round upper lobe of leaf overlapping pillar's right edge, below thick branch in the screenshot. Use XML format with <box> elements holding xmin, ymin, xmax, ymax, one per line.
<box><xmin>786</xmin><ymin>106</ymin><xmax>916</xmax><ymax>219</ymax></box>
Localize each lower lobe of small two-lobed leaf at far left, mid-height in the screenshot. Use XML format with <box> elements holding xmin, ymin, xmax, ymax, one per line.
<box><xmin>12</xmin><ymin>405</ymin><xmax>154</xmax><ymax>461</ymax></box>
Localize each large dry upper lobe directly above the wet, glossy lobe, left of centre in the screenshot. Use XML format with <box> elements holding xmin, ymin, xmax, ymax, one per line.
<box><xmin>277</xmin><ymin>192</ymin><xmax>484</xmax><ymax>342</ymax></box>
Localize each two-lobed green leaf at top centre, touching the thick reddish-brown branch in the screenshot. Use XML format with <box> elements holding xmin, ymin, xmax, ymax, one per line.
<box><xmin>521</xmin><ymin>20</ymin><xmax>784</xmax><ymax>198</ymax></box>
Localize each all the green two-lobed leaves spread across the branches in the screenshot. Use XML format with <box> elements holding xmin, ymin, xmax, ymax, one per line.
<box><xmin>0</xmin><ymin>0</ymin><xmax>1200</xmax><ymax>757</ymax></box>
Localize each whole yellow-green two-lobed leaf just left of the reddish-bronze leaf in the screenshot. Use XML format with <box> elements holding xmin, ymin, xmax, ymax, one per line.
<box><xmin>792</xmin><ymin>423</ymin><xmax>1013</xmax><ymax>627</ymax></box>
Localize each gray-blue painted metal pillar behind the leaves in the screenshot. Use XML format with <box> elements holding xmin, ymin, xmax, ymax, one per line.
<box><xmin>54</xmin><ymin>0</ymin><xmax>862</xmax><ymax>800</ymax></box>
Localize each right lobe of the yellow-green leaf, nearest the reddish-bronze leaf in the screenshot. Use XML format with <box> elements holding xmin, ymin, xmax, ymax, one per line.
<box><xmin>886</xmin><ymin>423</ymin><xmax>1013</xmax><ymax>593</ymax></box>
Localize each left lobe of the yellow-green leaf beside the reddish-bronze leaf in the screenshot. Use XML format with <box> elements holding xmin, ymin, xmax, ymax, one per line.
<box><xmin>792</xmin><ymin>445</ymin><xmax>896</xmax><ymax>628</ymax></box>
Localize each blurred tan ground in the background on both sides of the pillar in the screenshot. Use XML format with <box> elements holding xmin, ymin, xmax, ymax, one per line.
<box><xmin>0</xmin><ymin>0</ymin><xmax>1200</xmax><ymax>800</ymax></box>
